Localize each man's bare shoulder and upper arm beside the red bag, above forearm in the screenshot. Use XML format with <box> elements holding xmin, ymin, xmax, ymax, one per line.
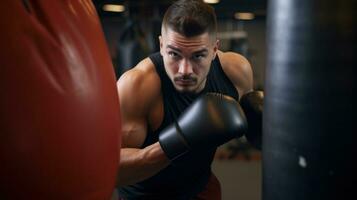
<box><xmin>117</xmin><ymin>58</ymin><xmax>161</xmax><ymax>148</ymax></box>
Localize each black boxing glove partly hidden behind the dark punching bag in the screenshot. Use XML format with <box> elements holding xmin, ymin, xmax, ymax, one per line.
<box><xmin>240</xmin><ymin>91</ymin><xmax>264</xmax><ymax>150</ymax></box>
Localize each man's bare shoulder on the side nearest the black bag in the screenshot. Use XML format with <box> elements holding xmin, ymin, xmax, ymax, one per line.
<box><xmin>218</xmin><ymin>51</ymin><xmax>253</xmax><ymax>96</ymax></box>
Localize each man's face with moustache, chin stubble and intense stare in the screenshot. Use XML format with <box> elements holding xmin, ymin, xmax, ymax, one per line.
<box><xmin>160</xmin><ymin>28</ymin><xmax>218</xmax><ymax>93</ymax></box>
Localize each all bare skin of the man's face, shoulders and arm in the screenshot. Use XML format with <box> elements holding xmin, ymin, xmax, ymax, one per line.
<box><xmin>117</xmin><ymin>28</ymin><xmax>253</xmax><ymax>186</ymax></box>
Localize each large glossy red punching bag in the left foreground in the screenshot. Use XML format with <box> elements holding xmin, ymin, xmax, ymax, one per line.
<box><xmin>0</xmin><ymin>0</ymin><xmax>120</xmax><ymax>200</ymax></box>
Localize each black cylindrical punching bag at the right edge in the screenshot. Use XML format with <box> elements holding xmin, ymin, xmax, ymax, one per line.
<box><xmin>263</xmin><ymin>0</ymin><xmax>357</xmax><ymax>200</ymax></box>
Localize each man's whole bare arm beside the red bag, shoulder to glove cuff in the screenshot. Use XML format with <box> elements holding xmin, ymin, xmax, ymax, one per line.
<box><xmin>117</xmin><ymin>59</ymin><xmax>169</xmax><ymax>186</ymax></box>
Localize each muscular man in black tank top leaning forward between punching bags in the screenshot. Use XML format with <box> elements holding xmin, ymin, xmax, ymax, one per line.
<box><xmin>117</xmin><ymin>0</ymin><xmax>253</xmax><ymax>199</ymax></box>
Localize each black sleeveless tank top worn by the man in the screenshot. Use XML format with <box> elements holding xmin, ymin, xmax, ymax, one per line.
<box><xmin>118</xmin><ymin>53</ymin><xmax>239</xmax><ymax>200</ymax></box>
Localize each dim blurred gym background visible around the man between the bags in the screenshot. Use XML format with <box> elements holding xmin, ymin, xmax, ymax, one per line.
<box><xmin>93</xmin><ymin>0</ymin><xmax>267</xmax><ymax>200</ymax></box>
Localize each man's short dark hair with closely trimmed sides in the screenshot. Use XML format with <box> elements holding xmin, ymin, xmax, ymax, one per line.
<box><xmin>162</xmin><ymin>0</ymin><xmax>217</xmax><ymax>37</ymax></box>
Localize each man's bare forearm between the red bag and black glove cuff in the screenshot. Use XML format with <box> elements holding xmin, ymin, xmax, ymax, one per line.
<box><xmin>117</xmin><ymin>142</ymin><xmax>170</xmax><ymax>187</ymax></box>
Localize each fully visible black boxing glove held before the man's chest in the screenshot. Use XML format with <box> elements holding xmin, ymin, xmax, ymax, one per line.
<box><xmin>159</xmin><ymin>93</ymin><xmax>247</xmax><ymax>161</ymax></box>
